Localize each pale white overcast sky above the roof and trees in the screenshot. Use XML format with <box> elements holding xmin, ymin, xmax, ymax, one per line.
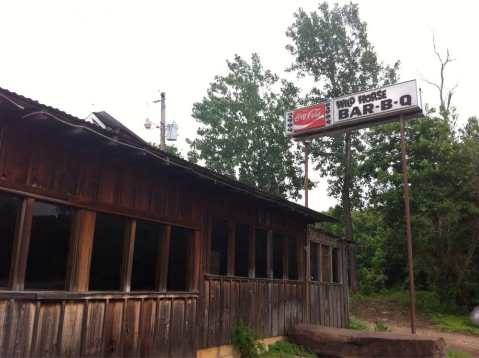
<box><xmin>0</xmin><ymin>0</ymin><xmax>479</xmax><ymax>210</ymax></box>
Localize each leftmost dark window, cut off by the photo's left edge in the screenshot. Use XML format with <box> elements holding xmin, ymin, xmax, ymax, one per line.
<box><xmin>0</xmin><ymin>193</ymin><xmax>21</xmax><ymax>287</ymax></box>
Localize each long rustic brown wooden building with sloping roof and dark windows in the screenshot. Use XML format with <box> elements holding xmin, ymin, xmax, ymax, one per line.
<box><xmin>0</xmin><ymin>89</ymin><xmax>348</xmax><ymax>357</ymax></box>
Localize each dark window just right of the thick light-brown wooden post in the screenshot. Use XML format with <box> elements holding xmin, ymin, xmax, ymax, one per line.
<box><xmin>90</xmin><ymin>213</ymin><xmax>127</xmax><ymax>291</ymax></box>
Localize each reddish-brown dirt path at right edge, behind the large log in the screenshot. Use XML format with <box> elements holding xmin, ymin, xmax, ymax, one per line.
<box><xmin>351</xmin><ymin>300</ymin><xmax>479</xmax><ymax>357</ymax></box>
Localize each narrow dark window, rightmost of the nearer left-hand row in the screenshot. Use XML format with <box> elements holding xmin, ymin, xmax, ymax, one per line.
<box><xmin>167</xmin><ymin>226</ymin><xmax>194</xmax><ymax>291</ymax></box>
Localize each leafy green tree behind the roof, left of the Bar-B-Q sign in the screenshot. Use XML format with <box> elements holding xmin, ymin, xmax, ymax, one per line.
<box><xmin>188</xmin><ymin>54</ymin><xmax>303</xmax><ymax>198</ymax></box>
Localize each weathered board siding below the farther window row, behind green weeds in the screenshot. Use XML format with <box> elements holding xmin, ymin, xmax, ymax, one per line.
<box><xmin>198</xmin><ymin>276</ymin><xmax>305</xmax><ymax>347</ymax></box>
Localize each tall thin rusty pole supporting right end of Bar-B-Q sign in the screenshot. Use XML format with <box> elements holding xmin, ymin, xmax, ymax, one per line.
<box><xmin>401</xmin><ymin>115</ymin><xmax>416</xmax><ymax>334</ymax></box>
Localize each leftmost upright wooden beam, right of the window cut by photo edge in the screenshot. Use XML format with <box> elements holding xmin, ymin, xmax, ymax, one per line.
<box><xmin>9</xmin><ymin>198</ymin><xmax>34</xmax><ymax>291</ymax></box>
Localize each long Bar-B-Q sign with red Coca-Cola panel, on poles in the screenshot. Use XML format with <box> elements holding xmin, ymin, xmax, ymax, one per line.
<box><xmin>286</xmin><ymin>80</ymin><xmax>422</xmax><ymax>137</ymax></box>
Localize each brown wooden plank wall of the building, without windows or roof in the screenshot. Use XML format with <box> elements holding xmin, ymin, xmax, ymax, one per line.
<box><xmin>0</xmin><ymin>114</ymin><xmax>347</xmax><ymax>357</ymax></box>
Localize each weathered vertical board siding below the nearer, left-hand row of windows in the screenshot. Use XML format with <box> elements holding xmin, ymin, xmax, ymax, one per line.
<box><xmin>0</xmin><ymin>295</ymin><xmax>197</xmax><ymax>357</ymax></box>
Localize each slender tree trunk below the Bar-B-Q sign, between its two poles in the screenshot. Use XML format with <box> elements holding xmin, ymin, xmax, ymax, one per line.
<box><xmin>341</xmin><ymin>130</ymin><xmax>358</xmax><ymax>291</ymax></box>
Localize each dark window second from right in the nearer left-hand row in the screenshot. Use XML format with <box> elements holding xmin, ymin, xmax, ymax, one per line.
<box><xmin>131</xmin><ymin>221</ymin><xmax>165</xmax><ymax>291</ymax></box>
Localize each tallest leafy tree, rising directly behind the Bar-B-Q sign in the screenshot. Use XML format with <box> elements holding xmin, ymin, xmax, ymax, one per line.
<box><xmin>286</xmin><ymin>2</ymin><xmax>399</xmax><ymax>287</ymax></box>
